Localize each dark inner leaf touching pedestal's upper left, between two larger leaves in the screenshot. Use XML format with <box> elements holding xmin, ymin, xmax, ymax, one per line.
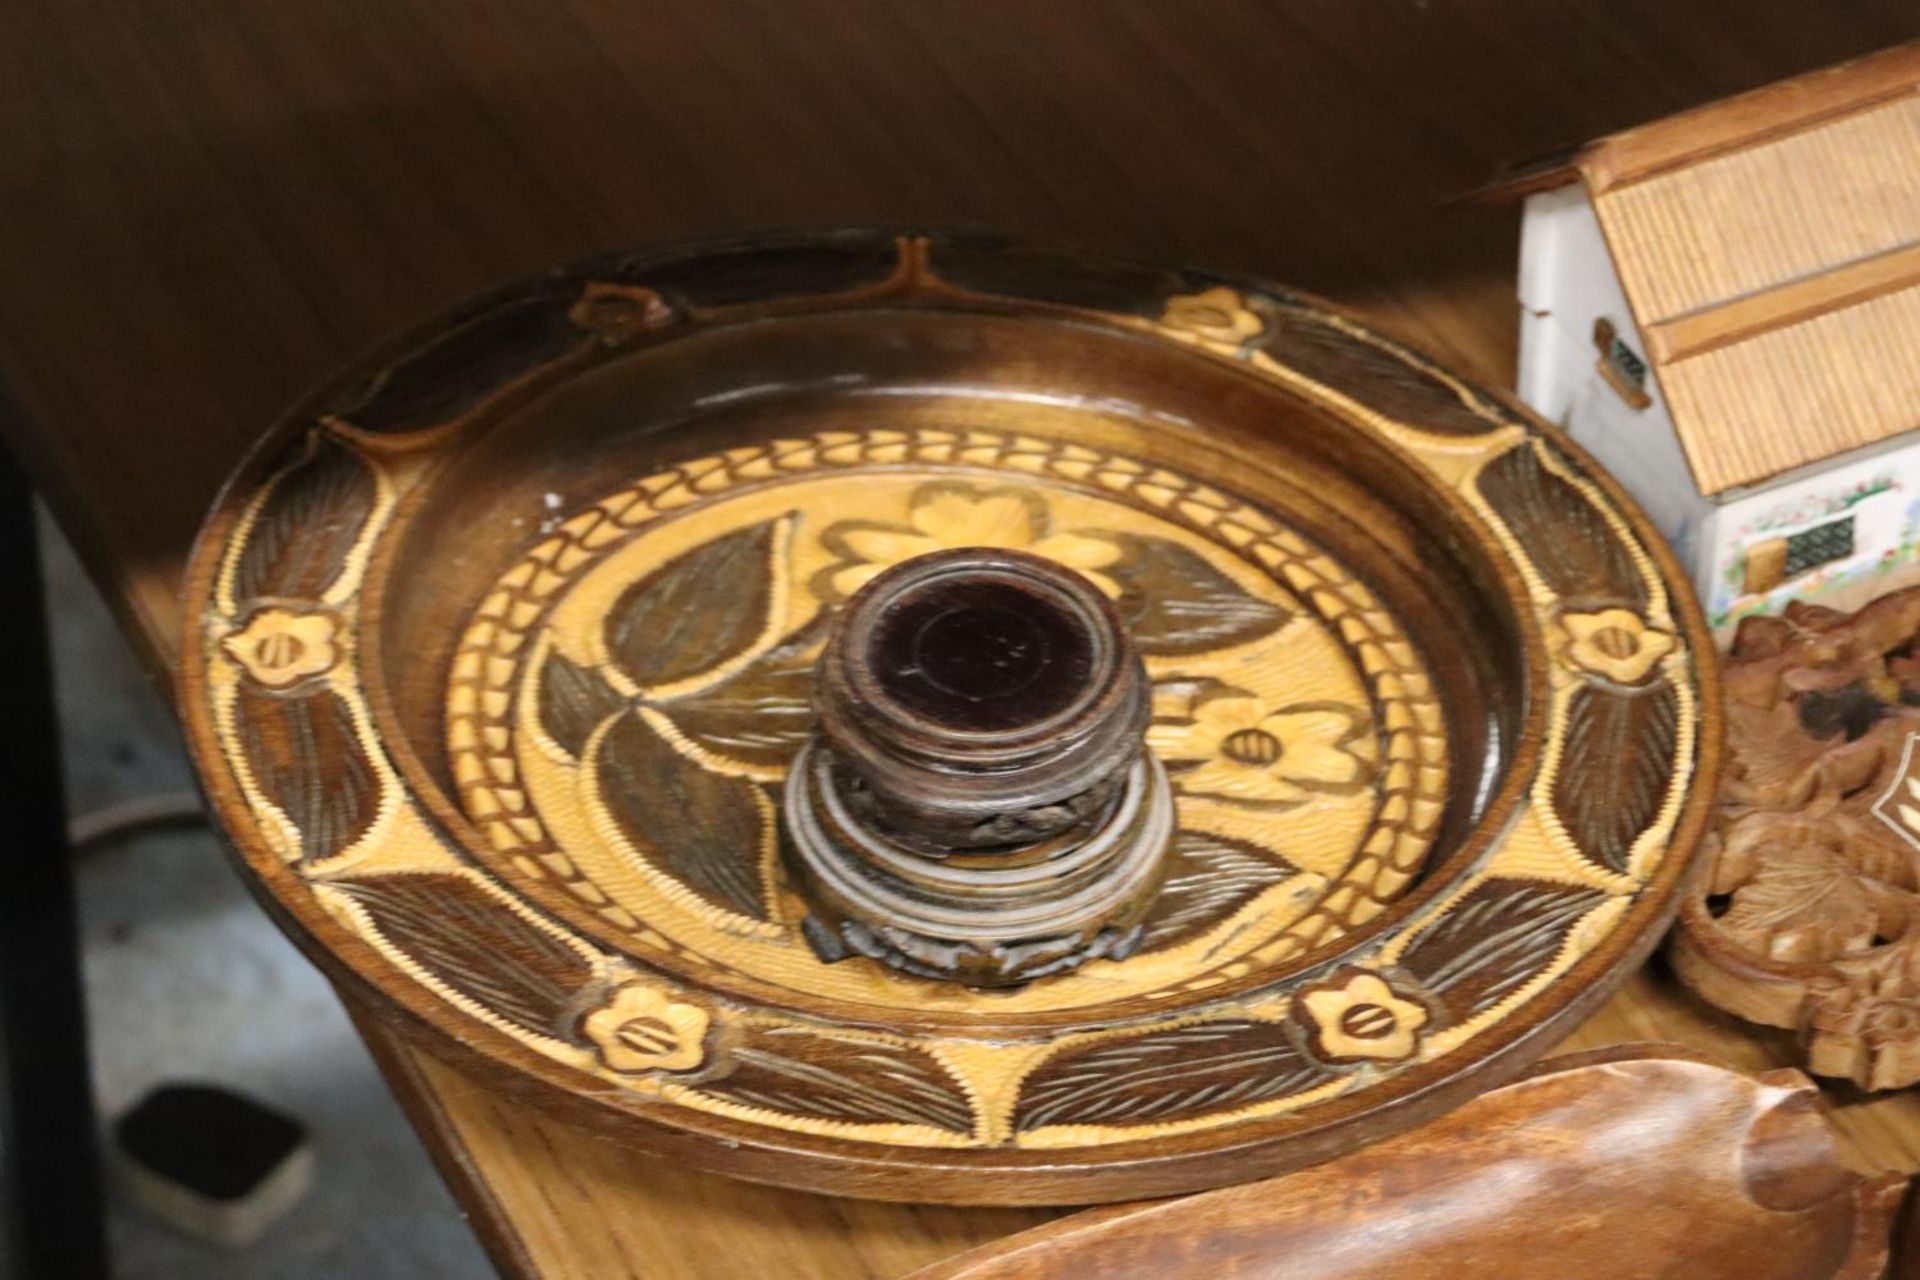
<box><xmin>660</xmin><ymin>614</ymin><xmax>826</xmax><ymax>766</ymax></box>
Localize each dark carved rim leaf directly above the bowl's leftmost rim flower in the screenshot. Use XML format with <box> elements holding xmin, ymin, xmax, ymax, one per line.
<box><xmin>234</xmin><ymin>432</ymin><xmax>378</xmax><ymax>610</ymax></box>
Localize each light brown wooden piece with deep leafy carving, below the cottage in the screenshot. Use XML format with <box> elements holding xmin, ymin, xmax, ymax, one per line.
<box><xmin>1670</xmin><ymin>587</ymin><xmax>1920</xmax><ymax>1088</ymax></box>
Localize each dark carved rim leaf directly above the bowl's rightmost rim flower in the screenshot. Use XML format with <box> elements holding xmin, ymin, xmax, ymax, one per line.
<box><xmin>1480</xmin><ymin>445</ymin><xmax>1647</xmax><ymax>612</ymax></box>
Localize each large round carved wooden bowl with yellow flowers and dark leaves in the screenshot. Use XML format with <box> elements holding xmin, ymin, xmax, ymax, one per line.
<box><xmin>182</xmin><ymin>232</ymin><xmax>1716</xmax><ymax>1203</ymax></box>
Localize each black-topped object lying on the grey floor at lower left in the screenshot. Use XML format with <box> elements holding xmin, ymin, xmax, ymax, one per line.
<box><xmin>113</xmin><ymin>1084</ymin><xmax>313</xmax><ymax>1247</ymax></box>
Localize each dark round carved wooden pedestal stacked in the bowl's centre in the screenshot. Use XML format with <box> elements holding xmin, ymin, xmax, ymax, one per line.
<box><xmin>781</xmin><ymin>547</ymin><xmax>1175</xmax><ymax>986</ymax></box>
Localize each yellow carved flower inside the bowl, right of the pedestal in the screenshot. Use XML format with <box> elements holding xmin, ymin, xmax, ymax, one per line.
<box><xmin>1146</xmin><ymin>693</ymin><xmax>1373</xmax><ymax>804</ymax></box>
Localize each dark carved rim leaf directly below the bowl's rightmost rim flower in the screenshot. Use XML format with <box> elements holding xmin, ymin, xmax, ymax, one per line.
<box><xmin>1553</xmin><ymin>683</ymin><xmax>1680</xmax><ymax>871</ymax></box>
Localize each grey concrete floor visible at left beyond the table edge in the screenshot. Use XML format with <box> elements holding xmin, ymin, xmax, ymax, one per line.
<box><xmin>42</xmin><ymin>522</ymin><xmax>493</xmax><ymax>1280</ymax></box>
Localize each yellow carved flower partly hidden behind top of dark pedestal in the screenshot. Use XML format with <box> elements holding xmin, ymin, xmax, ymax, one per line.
<box><xmin>822</xmin><ymin>482</ymin><xmax>1121</xmax><ymax>599</ymax></box>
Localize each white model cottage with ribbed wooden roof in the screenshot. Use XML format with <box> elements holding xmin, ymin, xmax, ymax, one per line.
<box><xmin>1507</xmin><ymin>46</ymin><xmax>1920</xmax><ymax>639</ymax></box>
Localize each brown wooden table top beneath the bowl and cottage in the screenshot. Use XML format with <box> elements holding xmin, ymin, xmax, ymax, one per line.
<box><xmin>11</xmin><ymin>0</ymin><xmax>1920</xmax><ymax>1280</ymax></box>
